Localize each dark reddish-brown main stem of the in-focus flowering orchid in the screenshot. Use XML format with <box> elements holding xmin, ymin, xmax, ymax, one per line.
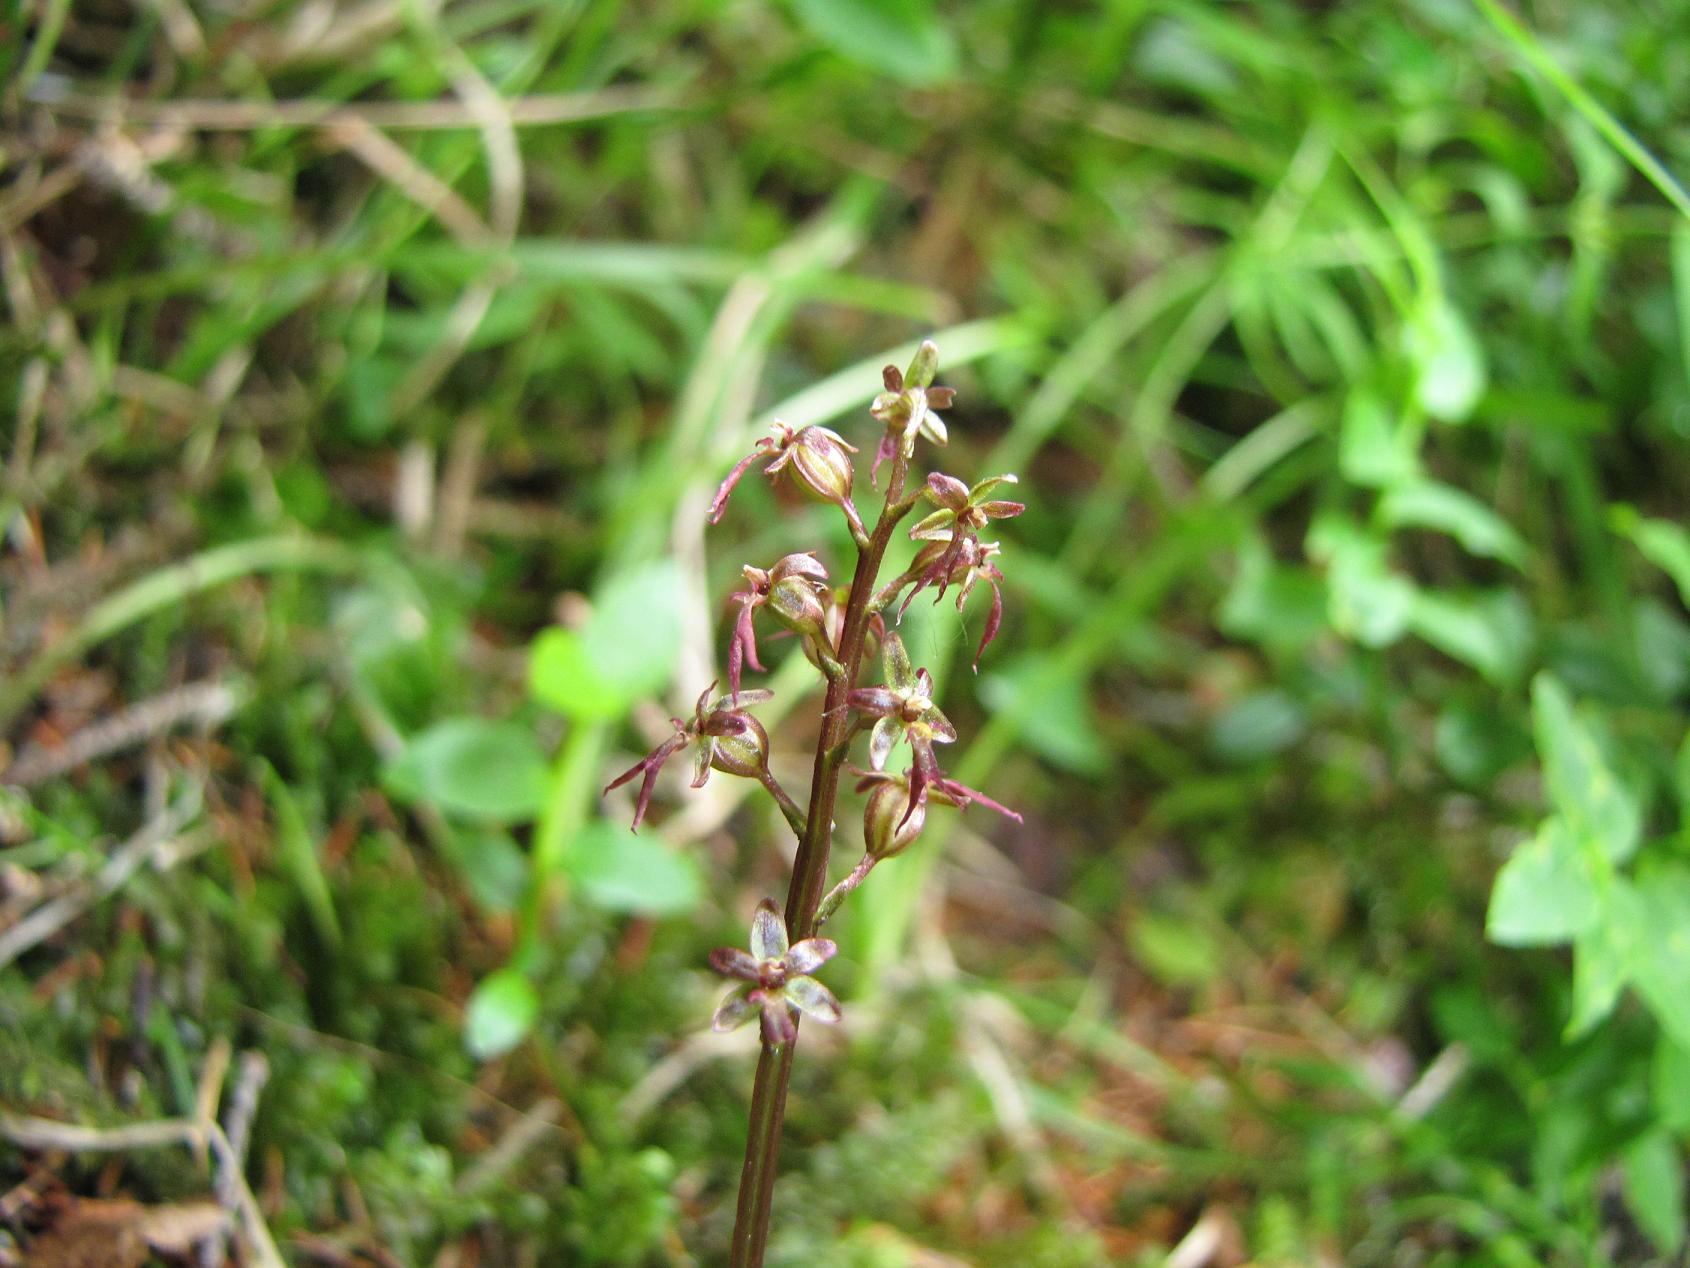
<box><xmin>728</xmin><ymin>453</ymin><xmax>914</xmax><ymax>1268</ymax></box>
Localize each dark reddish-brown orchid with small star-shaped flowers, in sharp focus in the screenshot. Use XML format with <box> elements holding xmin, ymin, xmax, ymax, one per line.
<box><xmin>605</xmin><ymin>342</ymin><xmax>1024</xmax><ymax>1266</ymax></box>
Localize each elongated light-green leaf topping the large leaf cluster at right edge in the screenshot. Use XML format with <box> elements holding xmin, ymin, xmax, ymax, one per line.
<box><xmin>1531</xmin><ymin>673</ymin><xmax>1643</xmax><ymax>862</ymax></box>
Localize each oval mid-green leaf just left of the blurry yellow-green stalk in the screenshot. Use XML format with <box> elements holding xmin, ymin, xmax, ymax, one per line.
<box><xmin>382</xmin><ymin>717</ymin><xmax>548</xmax><ymax>823</ymax></box>
